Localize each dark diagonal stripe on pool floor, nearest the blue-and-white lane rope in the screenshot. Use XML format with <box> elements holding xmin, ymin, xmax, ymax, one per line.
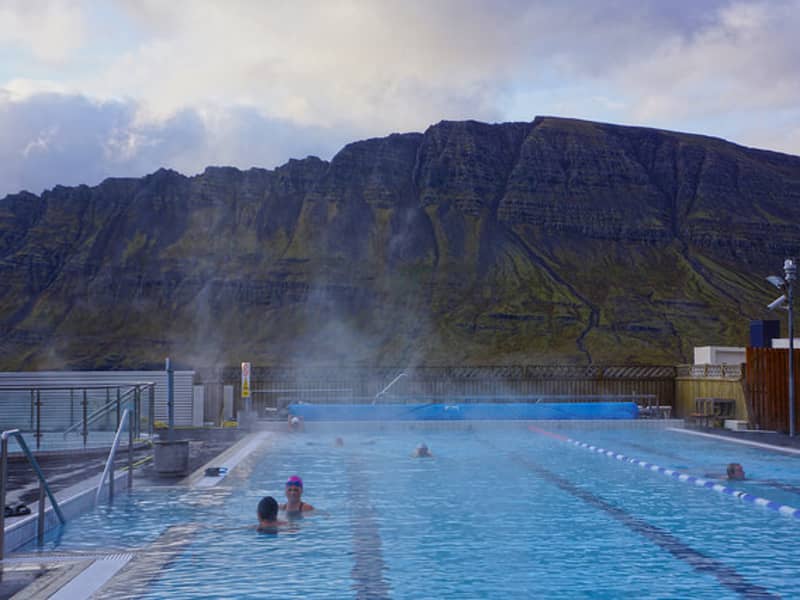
<box><xmin>516</xmin><ymin>454</ymin><xmax>780</xmax><ymax>598</ymax></box>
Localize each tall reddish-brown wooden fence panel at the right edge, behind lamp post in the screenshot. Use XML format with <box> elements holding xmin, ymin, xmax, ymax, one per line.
<box><xmin>746</xmin><ymin>348</ymin><xmax>800</xmax><ymax>433</ymax></box>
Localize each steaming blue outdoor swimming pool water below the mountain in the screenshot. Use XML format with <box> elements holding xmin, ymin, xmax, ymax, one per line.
<box><xmin>17</xmin><ymin>422</ymin><xmax>800</xmax><ymax>599</ymax></box>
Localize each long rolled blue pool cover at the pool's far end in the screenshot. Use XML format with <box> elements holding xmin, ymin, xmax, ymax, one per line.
<box><xmin>289</xmin><ymin>402</ymin><xmax>639</xmax><ymax>421</ymax></box>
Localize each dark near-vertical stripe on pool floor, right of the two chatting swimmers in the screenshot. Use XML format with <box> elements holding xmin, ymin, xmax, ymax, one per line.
<box><xmin>347</xmin><ymin>455</ymin><xmax>391</xmax><ymax>600</ymax></box>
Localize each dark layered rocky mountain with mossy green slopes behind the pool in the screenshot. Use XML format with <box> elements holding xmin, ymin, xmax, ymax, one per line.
<box><xmin>0</xmin><ymin>117</ymin><xmax>800</xmax><ymax>369</ymax></box>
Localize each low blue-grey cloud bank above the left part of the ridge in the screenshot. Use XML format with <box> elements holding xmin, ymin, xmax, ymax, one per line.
<box><xmin>0</xmin><ymin>94</ymin><xmax>349</xmax><ymax>197</ymax></box>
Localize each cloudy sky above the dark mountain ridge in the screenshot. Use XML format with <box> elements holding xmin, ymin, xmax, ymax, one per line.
<box><xmin>0</xmin><ymin>0</ymin><xmax>800</xmax><ymax>197</ymax></box>
